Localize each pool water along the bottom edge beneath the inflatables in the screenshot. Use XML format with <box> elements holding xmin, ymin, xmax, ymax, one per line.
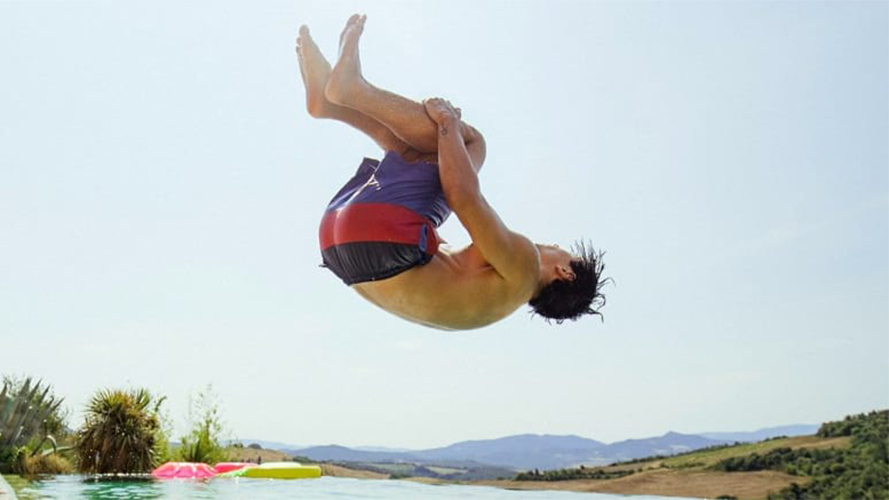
<box><xmin>8</xmin><ymin>476</ymin><xmax>696</xmax><ymax>500</ymax></box>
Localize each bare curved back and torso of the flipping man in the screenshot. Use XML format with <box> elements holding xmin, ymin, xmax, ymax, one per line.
<box><xmin>352</xmin><ymin>242</ymin><xmax>535</xmax><ymax>330</ymax></box>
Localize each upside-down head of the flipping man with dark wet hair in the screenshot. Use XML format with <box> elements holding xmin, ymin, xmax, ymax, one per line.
<box><xmin>528</xmin><ymin>241</ymin><xmax>611</xmax><ymax>324</ymax></box>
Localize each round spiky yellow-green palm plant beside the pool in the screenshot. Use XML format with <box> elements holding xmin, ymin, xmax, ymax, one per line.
<box><xmin>77</xmin><ymin>389</ymin><xmax>164</xmax><ymax>473</ymax></box>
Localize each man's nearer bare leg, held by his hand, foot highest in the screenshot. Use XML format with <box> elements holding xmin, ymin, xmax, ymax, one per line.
<box><xmin>325</xmin><ymin>15</ymin><xmax>450</xmax><ymax>153</ymax></box>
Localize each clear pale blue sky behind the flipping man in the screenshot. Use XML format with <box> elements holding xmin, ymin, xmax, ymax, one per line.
<box><xmin>0</xmin><ymin>1</ymin><xmax>889</xmax><ymax>448</ymax></box>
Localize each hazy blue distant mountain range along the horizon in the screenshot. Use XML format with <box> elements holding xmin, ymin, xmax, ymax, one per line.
<box><xmin>242</xmin><ymin>425</ymin><xmax>818</xmax><ymax>470</ymax></box>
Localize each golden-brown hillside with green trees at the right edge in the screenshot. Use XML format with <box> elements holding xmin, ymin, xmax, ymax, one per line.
<box><xmin>464</xmin><ymin>411</ymin><xmax>889</xmax><ymax>500</ymax></box>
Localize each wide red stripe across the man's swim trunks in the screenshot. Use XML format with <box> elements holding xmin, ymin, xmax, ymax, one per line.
<box><xmin>320</xmin><ymin>203</ymin><xmax>435</xmax><ymax>250</ymax></box>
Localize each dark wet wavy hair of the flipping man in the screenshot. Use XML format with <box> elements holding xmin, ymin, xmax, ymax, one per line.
<box><xmin>528</xmin><ymin>241</ymin><xmax>613</xmax><ymax>324</ymax></box>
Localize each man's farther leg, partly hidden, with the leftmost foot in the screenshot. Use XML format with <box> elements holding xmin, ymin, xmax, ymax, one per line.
<box><xmin>296</xmin><ymin>26</ymin><xmax>412</xmax><ymax>156</ymax></box>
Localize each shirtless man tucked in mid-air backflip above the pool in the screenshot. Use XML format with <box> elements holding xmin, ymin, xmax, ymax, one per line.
<box><xmin>297</xmin><ymin>15</ymin><xmax>608</xmax><ymax>330</ymax></box>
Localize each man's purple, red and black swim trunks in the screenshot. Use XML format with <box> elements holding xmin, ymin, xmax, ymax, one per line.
<box><xmin>319</xmin><ymin>151</ymin><xmax>451</xmax><ymax>285</ymax></box>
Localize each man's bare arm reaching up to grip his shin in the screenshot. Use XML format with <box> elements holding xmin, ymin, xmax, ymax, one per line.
<box><xmin>426</xmin><ymin>99</ymin><xmax>540</xmax><ymax>292</ymax></box>
